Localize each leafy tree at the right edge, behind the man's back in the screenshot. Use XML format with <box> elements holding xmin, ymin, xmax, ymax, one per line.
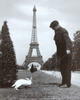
<box><xmin>72</xmin><ymin>31</ymin><xmax>80</xmax><ymax>69</ymax></box>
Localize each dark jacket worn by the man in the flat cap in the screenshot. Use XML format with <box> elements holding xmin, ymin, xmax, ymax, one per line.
<box><xmin>54</xmin><ymin>27</ymin><xmax>72</xmax><ymax>57</ymax></box>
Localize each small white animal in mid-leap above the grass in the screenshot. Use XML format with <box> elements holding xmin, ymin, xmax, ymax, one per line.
<box><xmin>12</xmin><ymin>77</ymin><xmax>32</xmax><ymax>90</ymax></box>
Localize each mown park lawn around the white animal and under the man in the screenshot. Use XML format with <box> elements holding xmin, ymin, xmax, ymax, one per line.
<box><xmin>0</xmin><ymin>70</ymin><xmax>80</xmax><ymax>100</ymax></box>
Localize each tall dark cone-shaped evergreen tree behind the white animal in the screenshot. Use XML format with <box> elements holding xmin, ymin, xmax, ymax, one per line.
<box><xmin>0</xmin><ymin>21</ymin><xmax>17</xmax><ymax>87</ymax></box>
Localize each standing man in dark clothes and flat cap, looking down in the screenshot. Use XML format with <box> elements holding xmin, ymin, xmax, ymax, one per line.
<box><xmin>50</xmin><ymin>20</ymin><xmax>72</xmax><ymax>87</ymax></box>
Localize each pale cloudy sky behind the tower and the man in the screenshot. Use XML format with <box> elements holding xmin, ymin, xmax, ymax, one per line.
<box><xmin>0</xmin><ymin>0</ymin><xmax>80</xmax><ymax>65</ymax></box>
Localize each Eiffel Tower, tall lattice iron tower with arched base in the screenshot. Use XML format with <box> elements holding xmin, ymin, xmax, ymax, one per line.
<box><xmin>23</xmin><ymin>6</ymin><xmax>44</xmax><ymax>68</ymax></box>
